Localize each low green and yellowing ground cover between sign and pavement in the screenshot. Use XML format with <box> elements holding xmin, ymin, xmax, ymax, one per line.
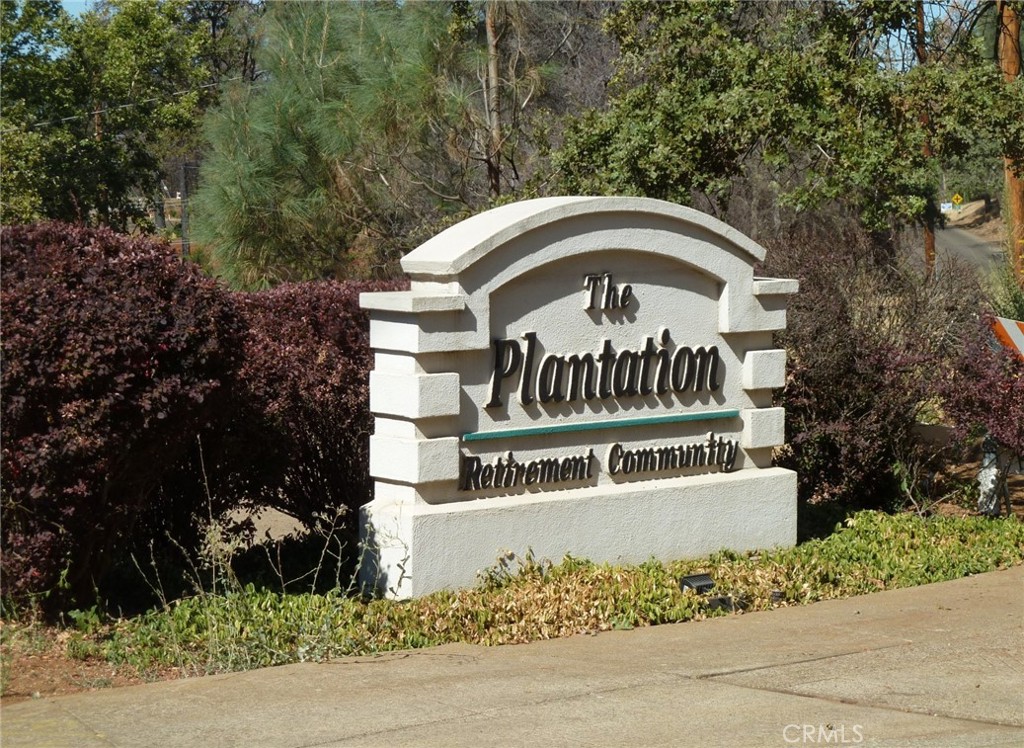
<box><xmin>5</xmin><ymin>511</ymin><xmax>1011</xmax><ymax>688</ymax></box>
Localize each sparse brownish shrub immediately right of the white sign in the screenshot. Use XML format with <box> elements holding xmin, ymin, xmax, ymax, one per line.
<box><xmin>768</xmin><ymin>221</ymin><xmax>980</xmax><ymax>508</ymax></box>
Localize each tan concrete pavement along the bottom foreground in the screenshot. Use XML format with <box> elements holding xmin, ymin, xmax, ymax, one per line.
<box><xmin>2</xmin><ymin>567</ymin><xmax>1024</xmax><ymax>748</ymax></box>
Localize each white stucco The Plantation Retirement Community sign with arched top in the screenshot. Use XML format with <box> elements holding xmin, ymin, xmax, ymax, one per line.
<box><xmin>361</xmin><ymin>198</ymin><xmax>797</xmax><ymax>597</ymax></box>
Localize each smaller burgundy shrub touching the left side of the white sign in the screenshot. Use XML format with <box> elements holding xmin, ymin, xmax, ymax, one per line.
<box><xmin>173</xmin><ymin>281</ymin><xmax>401</xmax><ymax>552</ymax></box>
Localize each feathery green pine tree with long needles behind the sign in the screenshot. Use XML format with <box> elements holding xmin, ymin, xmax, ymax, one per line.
<box><xmin>194</xmin><ymin>0</ymin><xmax>603</xmax><ymax>288</ymax></box>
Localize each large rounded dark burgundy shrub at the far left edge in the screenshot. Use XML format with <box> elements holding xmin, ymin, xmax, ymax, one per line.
<box><xmin>0</xmin><ymin>223</ymin><xmax>242</xmax><ymax>609</ymax></box>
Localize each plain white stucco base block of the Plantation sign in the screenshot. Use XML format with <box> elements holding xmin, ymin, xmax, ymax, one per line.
<box><xmin>360</xmin><ymin>467</ymin><xmax>797</xmax><ymax>599</ymax></box>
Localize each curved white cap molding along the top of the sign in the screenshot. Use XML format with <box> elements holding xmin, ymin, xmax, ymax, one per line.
<box><xmin>401</xmin><ymin>197</ymin><xmax>765</xmax><ymax>278</ymax></box>
